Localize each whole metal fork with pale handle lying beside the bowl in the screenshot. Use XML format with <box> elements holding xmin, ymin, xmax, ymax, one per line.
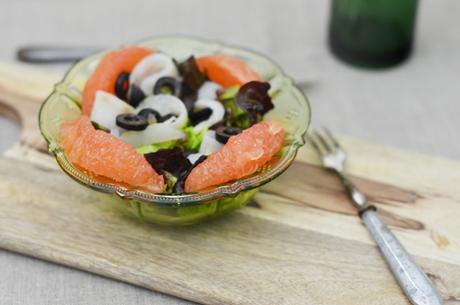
<box><xmin>307</xmin><ymin>128</ymin><xmax>443</xmax><ymax>305</ymax></box>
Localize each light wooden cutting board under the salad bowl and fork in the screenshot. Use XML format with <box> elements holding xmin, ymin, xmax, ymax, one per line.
<box><xmin>0</xmin><ymin>63</ymin><xmax>460</xmax><ymax>305</ymax></box>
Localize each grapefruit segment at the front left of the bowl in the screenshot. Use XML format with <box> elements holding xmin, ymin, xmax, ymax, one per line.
<box><xmin>60</xmin><ymin>115</ymin><xmax>164</xmax><ymax>193</ymax></box>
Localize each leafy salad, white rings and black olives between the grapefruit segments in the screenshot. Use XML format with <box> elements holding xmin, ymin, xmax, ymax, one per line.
<box><xmin>90</xmin><ymin>53</ymin><xmax>273</xmax><ymax>193</ymax></box>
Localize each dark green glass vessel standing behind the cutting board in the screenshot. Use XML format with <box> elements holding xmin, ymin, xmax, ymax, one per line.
<box><xmin>329</xmin><ymin>0</ymin><xmax>418</xmax><ymax>68</ymax></box>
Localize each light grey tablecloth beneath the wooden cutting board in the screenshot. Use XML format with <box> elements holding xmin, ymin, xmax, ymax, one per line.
<box><xmin>0</xmin><ymin>0</ymin><xmax>460</xmax><ymax>305</ymax></box>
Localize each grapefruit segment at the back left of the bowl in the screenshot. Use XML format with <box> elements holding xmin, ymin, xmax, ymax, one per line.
<box><xmin>82</xmin><ymin>47</ymin><xmax>153</xmax><ymax>116</ymax></box>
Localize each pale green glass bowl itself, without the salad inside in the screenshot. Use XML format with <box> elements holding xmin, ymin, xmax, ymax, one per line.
<box><xmin>39</xmin><ymin>36</ymin><xmax>310</xmax><ymax>225</ymax></box>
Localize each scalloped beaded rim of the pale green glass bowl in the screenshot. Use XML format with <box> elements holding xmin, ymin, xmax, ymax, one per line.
<box><xmin>39</xmin><ymin>36</ymin><xmax>311</xmax><ymax>207</ymax></box>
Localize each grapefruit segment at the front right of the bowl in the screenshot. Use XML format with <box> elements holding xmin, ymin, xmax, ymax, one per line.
<box><xmin>185</xmin><ymin>121</ymin><xmax>285</xmax><ymax>192</ymax></box>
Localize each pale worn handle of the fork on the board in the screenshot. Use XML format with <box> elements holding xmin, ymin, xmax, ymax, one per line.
<box><xmin>361</xmin><ymin>209</ymin><xmax>443</xmax><ymax>305</ymax></box>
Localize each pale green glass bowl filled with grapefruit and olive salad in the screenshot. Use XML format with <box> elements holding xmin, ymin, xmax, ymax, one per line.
<box><xmin>40</xmin><ymin>37</ymin><xmax>310</xmax><ymax>224</ymax></box>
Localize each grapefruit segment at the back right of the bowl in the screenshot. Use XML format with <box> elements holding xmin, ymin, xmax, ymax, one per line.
<box><xmin>197</xmin><ymin>55</ymin><xmax>262</xmax><ymax>88</ymax></box>
